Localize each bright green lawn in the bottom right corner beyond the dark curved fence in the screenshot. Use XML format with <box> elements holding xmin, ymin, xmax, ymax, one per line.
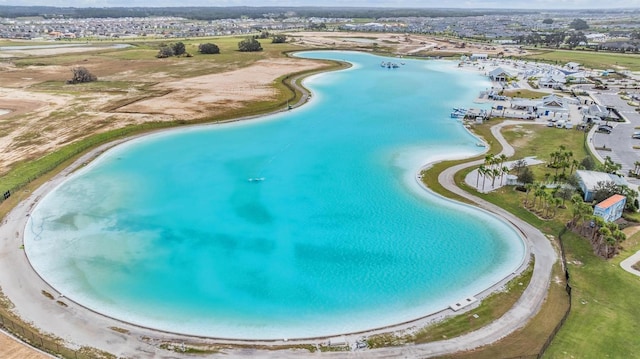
<box><xmin>545</xmin><ymin>234</ymin><xmax>640</xmax><ymax>359</ymax></box>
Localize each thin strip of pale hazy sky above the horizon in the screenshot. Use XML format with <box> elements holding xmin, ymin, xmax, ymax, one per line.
<box><xmin>0</xmin><ymin>0</ymin><xmax>640</xmax><ymax>9</ymax></box>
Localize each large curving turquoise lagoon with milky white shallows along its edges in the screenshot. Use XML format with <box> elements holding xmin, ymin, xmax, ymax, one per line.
<box><xmin>25</xmin><ymin>52</ymin><xmax>524</xmax><ymax>338</ymax></box>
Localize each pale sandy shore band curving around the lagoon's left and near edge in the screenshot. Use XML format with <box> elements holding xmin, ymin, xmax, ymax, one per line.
<box><xmin>0</xmin><ymin>132</ymin><xmax>529</xmax><ymax>355</ymax></box>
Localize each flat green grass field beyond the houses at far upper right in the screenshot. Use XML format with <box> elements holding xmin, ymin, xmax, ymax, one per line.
<box><xmin>522</xmin><ymin>49</ymin><xmax>640</xmax><ymax>71</ymax></box>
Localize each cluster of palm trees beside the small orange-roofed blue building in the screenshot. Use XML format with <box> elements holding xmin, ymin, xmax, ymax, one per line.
<box><xmin>568</xmin><ymin>195</ymin><xmax>627</xmax><ymax>259</ymax></box>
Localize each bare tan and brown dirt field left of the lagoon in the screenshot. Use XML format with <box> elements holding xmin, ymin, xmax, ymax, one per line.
<box><xmin>0</xmin><ymin>44</ymin><xmax>322</xmax><ymax>174</ymax></box>
